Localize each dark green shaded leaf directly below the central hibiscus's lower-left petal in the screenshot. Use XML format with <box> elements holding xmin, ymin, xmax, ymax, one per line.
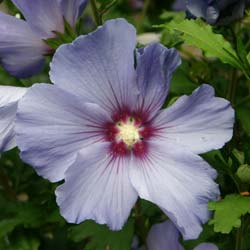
<box><xmin>69</xmin><ymin>220</ymin><xmax>134</xmax><ymax>250</ymax></box>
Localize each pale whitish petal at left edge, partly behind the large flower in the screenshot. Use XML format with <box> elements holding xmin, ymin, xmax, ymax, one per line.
<box><xmin>0</xmin><ymin>86</ymin><xmax>27</xmax><ymax>152</ymax></box>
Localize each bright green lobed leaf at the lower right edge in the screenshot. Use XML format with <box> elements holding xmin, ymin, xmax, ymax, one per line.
<box><xmin>208</xmin><ymin>194</ymin><xmax>250</xmax><ymax>233</ymax></box>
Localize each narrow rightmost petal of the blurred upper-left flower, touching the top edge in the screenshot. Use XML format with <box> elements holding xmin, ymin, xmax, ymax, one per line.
<box><xmin>59</xmin><ymin>0</ymin><xmax>88</xmax><ymax>27</ymax></box>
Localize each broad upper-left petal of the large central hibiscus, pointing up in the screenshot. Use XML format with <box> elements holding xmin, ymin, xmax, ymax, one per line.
<box><xmin>50</xmin><ymin>19</ymin><xmax>136</xmax><ymax>112</ymax></box>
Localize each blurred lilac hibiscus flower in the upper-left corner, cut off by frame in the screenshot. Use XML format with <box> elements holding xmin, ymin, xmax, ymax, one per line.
<box><xmin>0</xmin><ymin>0</ymin><xmax>88</xmax><ymax>78</ymax></box>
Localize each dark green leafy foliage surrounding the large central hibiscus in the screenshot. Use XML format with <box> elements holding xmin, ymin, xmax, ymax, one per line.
<box><xmin>0</xmin><ymin>0</ymin><xmax>250</xmax><ymax>250</ymax></box>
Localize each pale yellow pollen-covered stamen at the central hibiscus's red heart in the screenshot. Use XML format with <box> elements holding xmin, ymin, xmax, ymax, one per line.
<box><xmin>116</xmin><ymin>117</ymin><xmax>140</xmax><ymax>148</ymax></box>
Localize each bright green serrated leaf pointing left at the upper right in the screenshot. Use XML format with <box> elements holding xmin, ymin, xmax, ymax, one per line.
<box><xmin>164</xmin><ymin>19</ymin><xmax>242</xmax><ymax>69</ymax></box>
